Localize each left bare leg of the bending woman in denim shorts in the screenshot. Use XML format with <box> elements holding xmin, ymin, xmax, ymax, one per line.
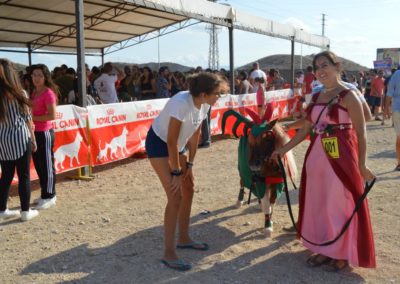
<box><xmin>149</xmin><ymin>157</ymin><xmax>181</xmax><ymax>261</ymax></box>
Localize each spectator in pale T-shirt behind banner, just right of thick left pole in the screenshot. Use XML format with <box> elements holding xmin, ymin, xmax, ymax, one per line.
<box><xmin>94</xmin><ymin>62</ymin><xmax>124</xmax><ymax>104</ymax></box>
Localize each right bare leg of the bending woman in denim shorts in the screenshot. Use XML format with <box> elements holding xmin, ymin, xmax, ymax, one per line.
<box><xmin>178</xmin><ymin>155</ymin><xmax>194</xmax><ymax>245</ymax></box>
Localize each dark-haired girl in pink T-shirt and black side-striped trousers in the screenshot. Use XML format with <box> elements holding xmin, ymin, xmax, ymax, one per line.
<box><xmin>31</xmin><ymin>64</ymin><xmax>57</xmax><ymax>209</ymax></box>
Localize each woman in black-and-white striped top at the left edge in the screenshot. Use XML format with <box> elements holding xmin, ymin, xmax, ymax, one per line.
<box><xmin>0</xmin><ymin>59</ymin><xmax>39</xmax><ymax>221</ymax></box>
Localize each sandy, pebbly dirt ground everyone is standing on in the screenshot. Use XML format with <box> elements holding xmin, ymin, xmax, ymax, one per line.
<box><xmin>0</xmin><ymin>118</ymin><xmax>400</xmax><ymax>284</ymax></box>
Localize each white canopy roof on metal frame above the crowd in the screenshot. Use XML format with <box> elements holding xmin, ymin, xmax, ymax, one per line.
<box><xmin>0</xmin><ymin>0</ymin><xmax>329</xmax><ymax>53</ymax></box>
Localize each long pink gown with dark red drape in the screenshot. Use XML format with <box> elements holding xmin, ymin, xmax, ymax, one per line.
<box><xmin>299</xmin><ymin>91</ymin><xmax>376</xmax><ymax>267</ymax></box>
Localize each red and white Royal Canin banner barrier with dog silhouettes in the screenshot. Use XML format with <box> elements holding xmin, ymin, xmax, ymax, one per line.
<box><xmin>7</xmin><ymin>89</ymin><xmax>301</xmax><ymax>183</ymax></box>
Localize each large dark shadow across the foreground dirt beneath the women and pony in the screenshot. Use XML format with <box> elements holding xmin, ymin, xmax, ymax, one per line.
<box><xmin>21</xmin><ymin>203</ymin><xmax>364</xmax><ymax>283</ymax></box>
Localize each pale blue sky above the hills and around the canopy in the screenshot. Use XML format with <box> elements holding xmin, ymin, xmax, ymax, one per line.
<box><xmin>0</xmin><ymin>0</ymin><xmax>400</xmax><ymax>68</ymax></box>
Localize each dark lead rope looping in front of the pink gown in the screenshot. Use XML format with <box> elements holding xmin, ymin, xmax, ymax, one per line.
<box><xmin>278</xmin><ymin>156</ymin><xmax>376</xmax><ymax>246</ymax></box>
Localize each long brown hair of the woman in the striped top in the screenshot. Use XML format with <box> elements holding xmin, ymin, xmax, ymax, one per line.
<box><xmin>0</xmin><ymin>58</ymin><xmax>31</xmax><ymax>122</ymax></box>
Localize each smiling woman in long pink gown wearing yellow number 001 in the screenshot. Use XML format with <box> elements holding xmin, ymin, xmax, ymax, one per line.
<box><xmin>272</xmin><ymin>51</ymin><xmax>376</xmax><ymax>271</ymax></box>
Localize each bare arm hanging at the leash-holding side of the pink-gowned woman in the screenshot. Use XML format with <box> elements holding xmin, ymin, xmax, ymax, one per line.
<box><xmin>343</xmin><ymin>91</ymin><xmax>374</xmax><ymax>180</ymax></box>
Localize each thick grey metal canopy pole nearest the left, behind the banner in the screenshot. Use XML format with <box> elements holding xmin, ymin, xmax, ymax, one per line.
<box><xmin>75</xmin><ymin>0</ymin><xmax>86</xmax><ymax>107</ymax></box>
